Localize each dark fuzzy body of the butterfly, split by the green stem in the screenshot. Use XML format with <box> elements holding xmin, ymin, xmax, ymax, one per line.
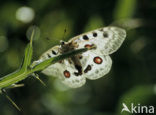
<box><xmin>60</xmin><ymin>42</ymin><xmax>82</xmax><ymax>76</ymax></box>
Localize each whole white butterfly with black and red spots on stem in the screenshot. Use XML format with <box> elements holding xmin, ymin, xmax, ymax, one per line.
<box><xmin>34</xmin><ymin>26</ymin><xmax>126</xmax><ymax>88</ymax></box>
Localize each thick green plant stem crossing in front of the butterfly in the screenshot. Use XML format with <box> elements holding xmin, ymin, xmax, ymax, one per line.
<box><xmin>0</xmin><ymin>48</ymin><xmax>88</xmax><ymax>90</ymax></box>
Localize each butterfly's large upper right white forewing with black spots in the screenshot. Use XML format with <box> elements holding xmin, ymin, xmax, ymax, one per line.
<box><xmin>69</xmin><ymin>26</ymin><xmax>126</xmax><ymax>55</ymax></box>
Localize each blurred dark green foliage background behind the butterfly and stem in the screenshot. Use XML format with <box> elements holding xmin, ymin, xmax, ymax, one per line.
<box><xmin>0</xmin><ymin>0</ymin><xmax>156</xmax><ymax>115</ymax></box>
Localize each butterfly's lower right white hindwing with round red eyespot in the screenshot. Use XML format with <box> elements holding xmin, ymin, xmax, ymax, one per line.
<box><xmin>81</xmin><ymin>51</ymin><xmax>112</xmax><ymax>80</ymax></box>
